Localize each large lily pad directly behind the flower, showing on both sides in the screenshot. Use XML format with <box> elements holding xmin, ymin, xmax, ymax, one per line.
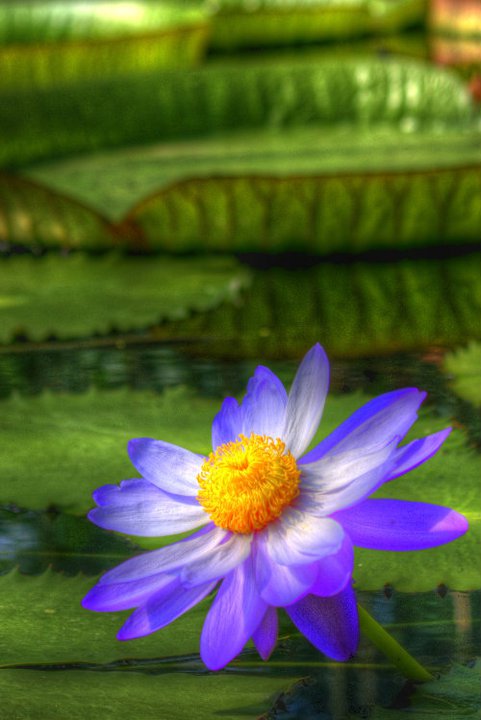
<box><xmin>0</xmin><ymin>388</ymin><xmax>481</xmax><ymax>591</ymax></box>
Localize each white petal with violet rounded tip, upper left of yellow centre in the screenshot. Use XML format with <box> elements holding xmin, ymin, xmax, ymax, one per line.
<box><xmin>128</xmin><ymin>438</ymin><xmax>203</xmax><ymax>496</ymax></box>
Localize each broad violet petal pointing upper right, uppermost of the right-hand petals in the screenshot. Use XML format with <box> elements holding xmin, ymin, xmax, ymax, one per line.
<box><xmin>302</xmin><ymin>388</ymin><xmax>426</xmax><ymax>464</ymax></box>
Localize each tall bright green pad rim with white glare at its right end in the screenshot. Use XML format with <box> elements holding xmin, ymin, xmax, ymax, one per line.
<box><xmin>0</xmin><ymin>56</ymin><xmax>473</xmax><ymax>167</ymax></box>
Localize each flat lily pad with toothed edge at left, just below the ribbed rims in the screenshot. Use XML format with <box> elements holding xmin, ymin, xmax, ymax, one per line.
<box><xmin>0</xmin><ymin>254</ymin><xmax>249</xmax><ymax>342</ymax></box>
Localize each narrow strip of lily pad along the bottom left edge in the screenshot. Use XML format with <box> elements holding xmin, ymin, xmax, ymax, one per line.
<box><xmin>0</xmin><ymin>670</ymin><xmax>288</xmax><ymax>720</ymax></box>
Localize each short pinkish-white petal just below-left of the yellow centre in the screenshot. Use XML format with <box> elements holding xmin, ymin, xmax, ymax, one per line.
<box><xmin>180</xmin><ymin>534</ymin><xmax>252</xmax><ymax>587</ymax></box>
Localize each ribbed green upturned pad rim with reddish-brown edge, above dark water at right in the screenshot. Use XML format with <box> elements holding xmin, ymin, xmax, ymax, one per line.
<box><xmin>127</xmin><ymin>149</ymin><xmax>481</xmax><ymax>255</ymax></box>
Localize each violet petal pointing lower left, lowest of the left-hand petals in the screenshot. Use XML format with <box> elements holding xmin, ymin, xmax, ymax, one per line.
<box><xmin>117</xmin><ymin>580</ymin><xmax>215</xmax><ymax>640</ymax></box>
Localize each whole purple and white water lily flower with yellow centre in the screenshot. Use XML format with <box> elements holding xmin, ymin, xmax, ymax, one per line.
<box><xmin>83</xmin><ymin>345</ymin><xmax>467</xmax><ymax>670</ymax></box>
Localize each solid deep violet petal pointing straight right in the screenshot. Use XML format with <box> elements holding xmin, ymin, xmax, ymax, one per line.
<box><xmin>334</xmin><ymin>499</ymin><xmax>468</xmax><ymax>550</ymax></box>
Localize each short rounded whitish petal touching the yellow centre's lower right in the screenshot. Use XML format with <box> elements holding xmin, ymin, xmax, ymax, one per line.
<box><xmin>265</xmin><ymin>508</ymin><xmax>344</xmax><ymax>565</ymax></box>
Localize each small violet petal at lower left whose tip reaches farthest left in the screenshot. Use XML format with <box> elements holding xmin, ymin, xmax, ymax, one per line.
<box><xmin>82</xmin><ymin>573</ymin><xmax>175</xmax><ymax>612</ymax></box>
